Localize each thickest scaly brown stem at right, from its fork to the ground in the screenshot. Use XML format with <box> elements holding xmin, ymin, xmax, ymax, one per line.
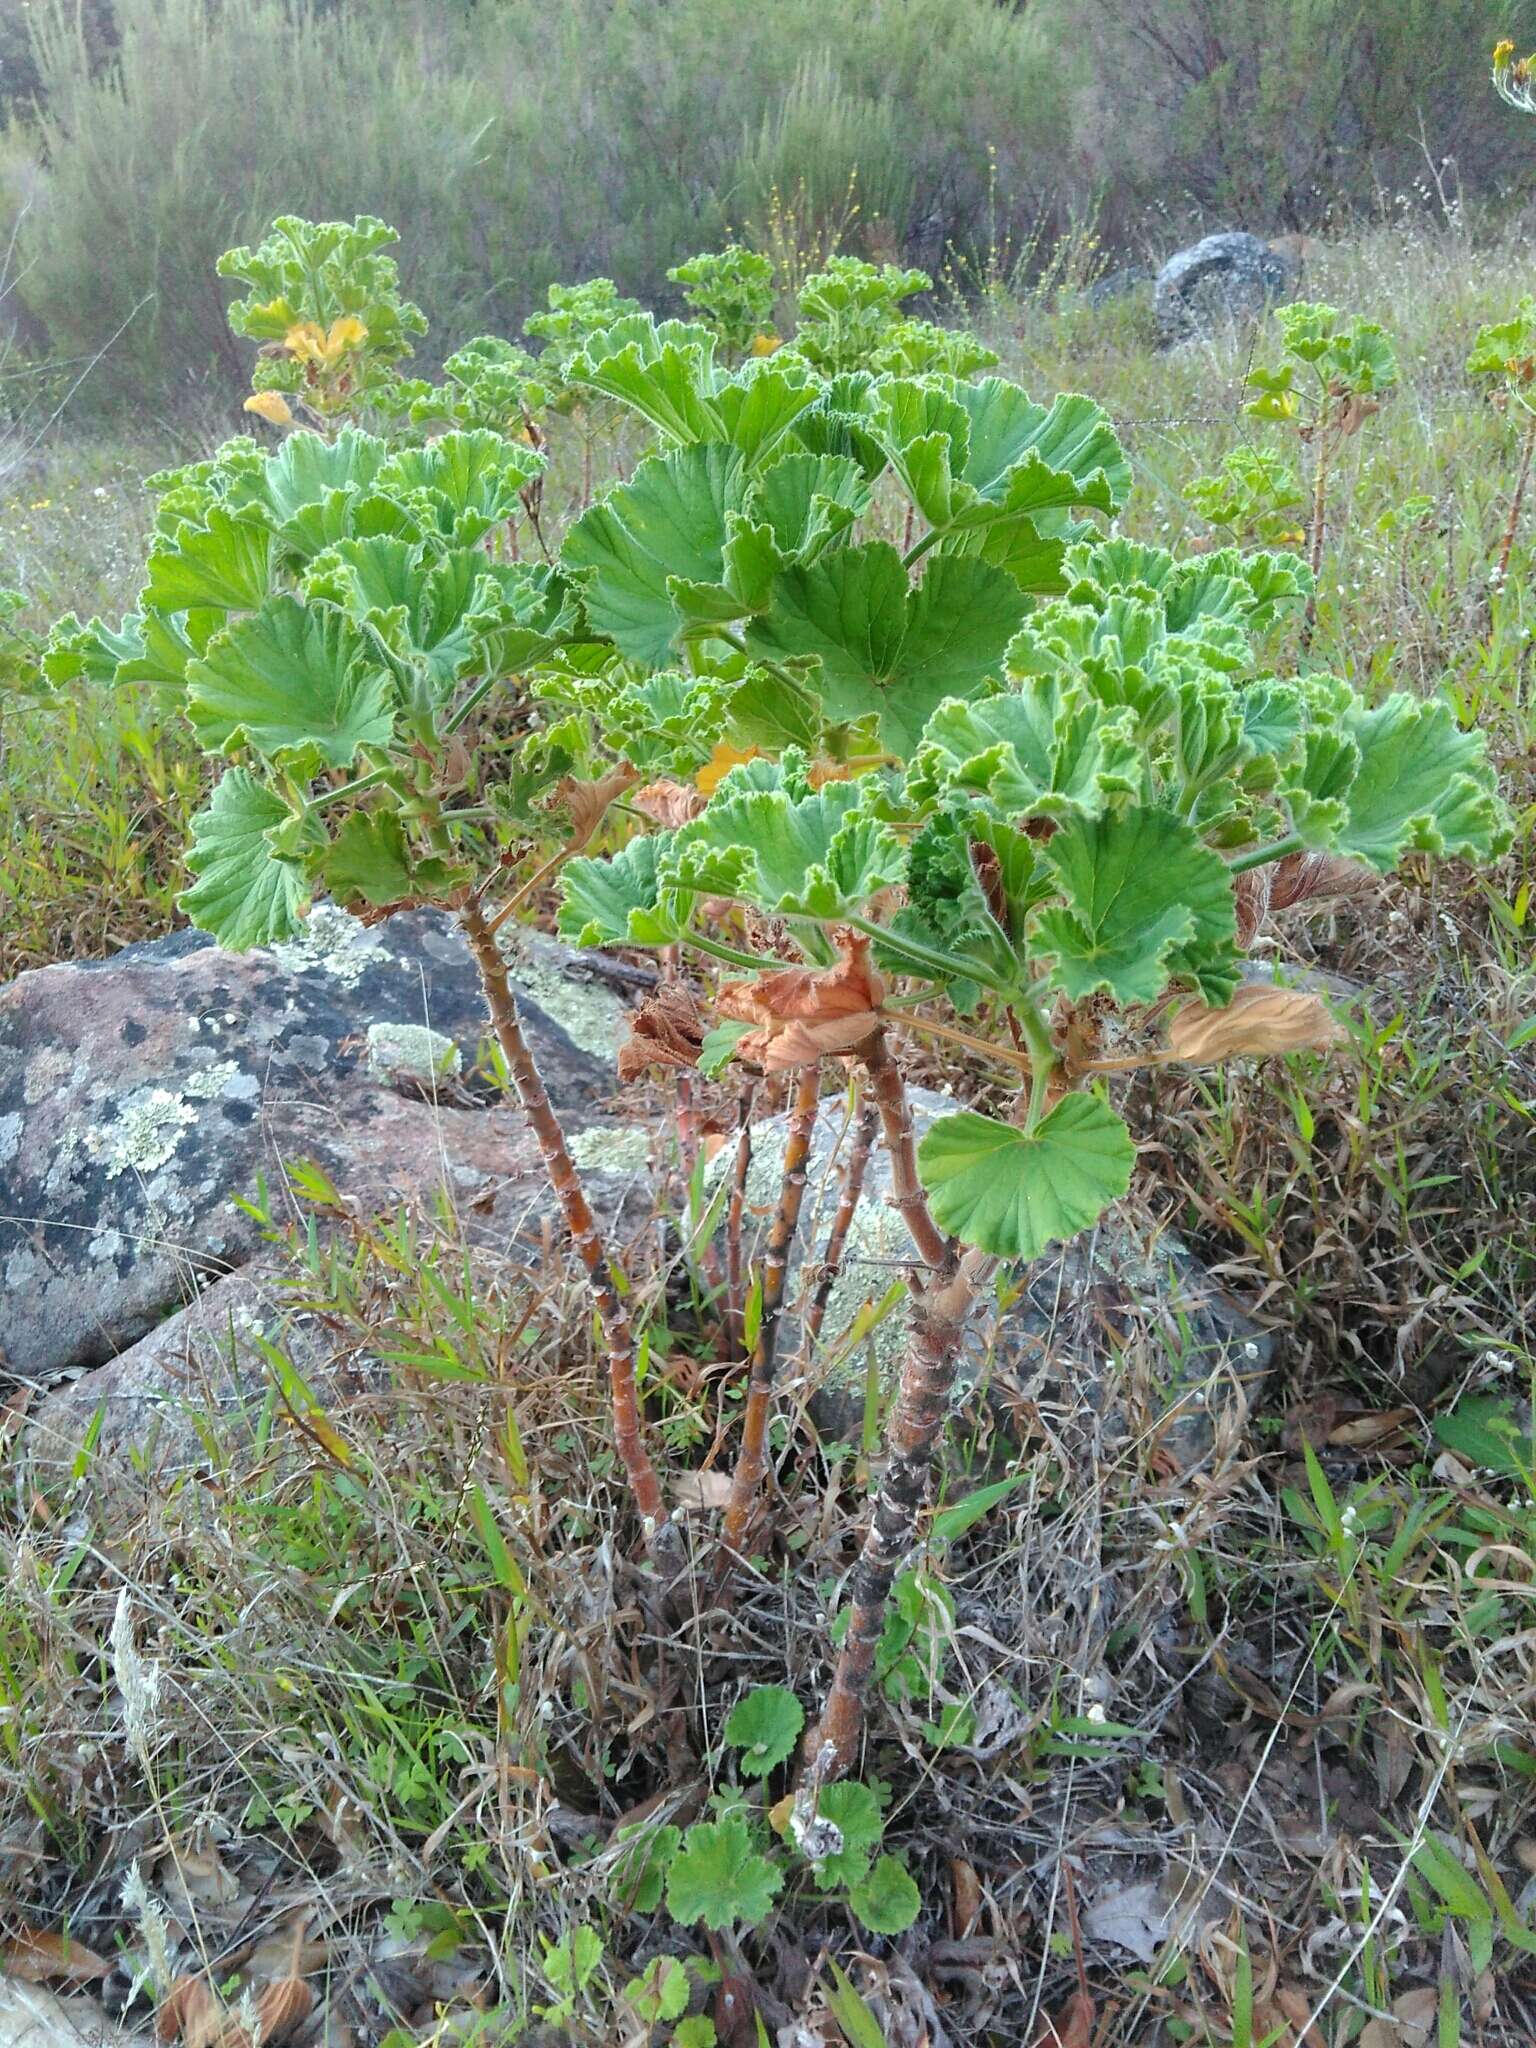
<box><xmin>805</xmin><ymin>1247</ymin><xmax>997</xmax><ymax>1786</ymax></box>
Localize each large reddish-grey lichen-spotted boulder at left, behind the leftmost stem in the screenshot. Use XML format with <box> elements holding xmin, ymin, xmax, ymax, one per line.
<box><xmin>0</xmin><ymin>921</ymin><xmax>625</xmax><ymax>1378</ymax></box>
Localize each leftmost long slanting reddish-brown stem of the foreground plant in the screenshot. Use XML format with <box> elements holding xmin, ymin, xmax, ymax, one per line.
<box><xmin>459</xmin><ymin>897</ymin><xmax>682</xmax><ymax>1581</ymax></box>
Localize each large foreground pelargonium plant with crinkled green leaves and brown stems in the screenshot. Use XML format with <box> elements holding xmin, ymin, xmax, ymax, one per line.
<box><xmin>49</xmin><ymin>216</ymin><xmax>1507</xmax><ymax>1790</ymax></box>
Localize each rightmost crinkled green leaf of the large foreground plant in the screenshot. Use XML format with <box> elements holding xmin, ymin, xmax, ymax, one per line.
<box><xmin>1333</xmin><ymin>692</ymin><xmax>1513</xmax><ymax>874</ymax></box>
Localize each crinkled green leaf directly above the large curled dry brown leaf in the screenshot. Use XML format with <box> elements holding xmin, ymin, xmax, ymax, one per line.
<box><xmin>664</xmin><ymin>770</ymin><xmax>905</xmax><ymax>920</ymax></box>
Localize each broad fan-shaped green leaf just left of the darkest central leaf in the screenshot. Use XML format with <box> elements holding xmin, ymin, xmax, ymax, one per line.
<box><xmin>561</xmin><ymin>442</ymin><xmax>750</xmax><ymax>668</ymax></box>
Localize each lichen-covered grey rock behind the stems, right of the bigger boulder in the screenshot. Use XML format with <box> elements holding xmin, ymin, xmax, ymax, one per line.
<box><xmin>711</xmin><ymin>1090</ymin><xmax>1274</xmax><ymax>1464</ymax></box>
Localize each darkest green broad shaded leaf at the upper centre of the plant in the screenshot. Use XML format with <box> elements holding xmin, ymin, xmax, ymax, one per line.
<box><xmin>745</xmin><ymin>541</ymin><xmax>1028</xmax><ymax>758</ymax></box>
